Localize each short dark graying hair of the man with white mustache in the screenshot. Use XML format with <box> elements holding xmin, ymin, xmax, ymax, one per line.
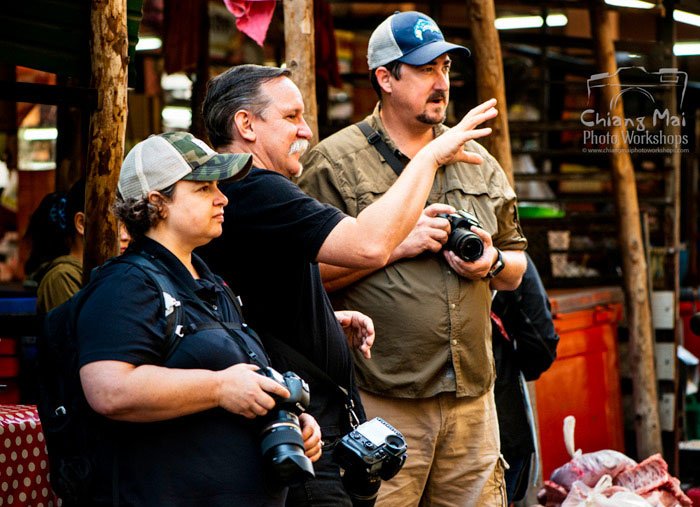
<box><xmin>202</xmin><ymin>64</ymin><xmax>291</xmax><ymax>148</ymax></box>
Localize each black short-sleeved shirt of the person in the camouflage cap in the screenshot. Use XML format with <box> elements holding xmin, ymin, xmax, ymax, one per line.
<box><xmin>78</xmin><ymin>238</ymin><xmax>285</xmax><ymax>507</ymax></box>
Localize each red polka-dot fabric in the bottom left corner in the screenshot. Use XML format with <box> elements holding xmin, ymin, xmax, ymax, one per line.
<box><xmin>0</xmin><ymin>405</ymin><xmax>58</xmax><ymax>507</ymax></box>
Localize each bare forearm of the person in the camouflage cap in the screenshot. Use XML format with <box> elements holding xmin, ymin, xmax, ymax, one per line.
<box><xmin>80</xmin><ymin>361</ymin><xmax>220</xmax><ymax>422</ymax></box>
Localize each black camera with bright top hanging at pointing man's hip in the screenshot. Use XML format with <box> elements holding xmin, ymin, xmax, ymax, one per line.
<box><xmin>333</xmin><ymin>417</ymin><xmax>406</xmax><ymax>507</ymax></box>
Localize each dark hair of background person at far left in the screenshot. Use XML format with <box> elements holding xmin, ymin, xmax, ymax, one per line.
<box><xmin>24</xmin><ymin>179</ymin><xmax>85</xmax><ymax>274</ymax></box>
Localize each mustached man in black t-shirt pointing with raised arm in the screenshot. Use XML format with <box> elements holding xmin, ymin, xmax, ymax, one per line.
<box><xmin>200</xmin><ymin>65</ymin><xmax>495</xmax><ymax>507</ymax></box>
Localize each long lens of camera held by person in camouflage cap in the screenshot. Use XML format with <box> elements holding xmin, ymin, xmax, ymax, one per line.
<box><xmin>260</xmin><ymin>410</ymin><xmax>314</xmax><ymax>484</ymax></box>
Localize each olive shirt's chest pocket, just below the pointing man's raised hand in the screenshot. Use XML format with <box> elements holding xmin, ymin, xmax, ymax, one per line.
<box><xmin>429</xmin><ymin>174</ymin><xmax>500</xmax><ymax>235</ymax></box>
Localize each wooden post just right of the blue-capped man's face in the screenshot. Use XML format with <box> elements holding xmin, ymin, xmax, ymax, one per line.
<box><xmin>468</xmin><ymin>0</ymin><xmax>515</xmax><ymax>188</ymax></box>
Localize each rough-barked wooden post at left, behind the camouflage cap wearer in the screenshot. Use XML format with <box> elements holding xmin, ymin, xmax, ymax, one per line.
<box><xmin>83</xmin><ymin>0</ymin><xmax>129</xmax><ymax>281</ymax></box>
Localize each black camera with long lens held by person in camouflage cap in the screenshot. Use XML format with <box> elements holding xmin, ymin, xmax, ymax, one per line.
<box><xmin>258</xmin><ymin>367</ymin><xmax>315</xmax><ymax>485</ymax></box>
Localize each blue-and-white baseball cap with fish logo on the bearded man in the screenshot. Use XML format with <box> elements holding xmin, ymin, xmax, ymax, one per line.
<box><xmin>367</xmin><ymin>11</ymin><xmax>470</xmax><ymax>70</ymax></box>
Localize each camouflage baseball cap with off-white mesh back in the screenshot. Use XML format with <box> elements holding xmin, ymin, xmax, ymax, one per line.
<box><xmin>119</xmin><ymin>132</ymin><xmax>253</xmax><ymax>199</ymax></box>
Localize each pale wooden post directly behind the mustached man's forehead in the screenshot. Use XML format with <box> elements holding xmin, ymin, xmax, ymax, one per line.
<box><xmin>284</xmin><ymin>0</ymin><xmax>318</xmax><ymax>146</ymax></box>
